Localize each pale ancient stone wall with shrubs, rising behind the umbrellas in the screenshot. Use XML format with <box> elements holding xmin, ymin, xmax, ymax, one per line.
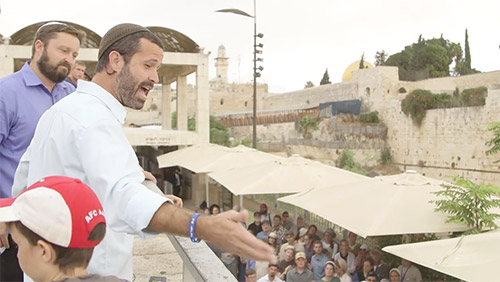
<box><xmin>225</xmin><ymin>67</ymin><xmax>500</xmax><ymax>185</ymax></box>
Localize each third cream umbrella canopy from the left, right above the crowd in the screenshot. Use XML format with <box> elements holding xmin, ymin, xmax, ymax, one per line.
<box><xmin>278</xmin><ymin>171</ymin><xmax>474</xmax><ymax>237</ymax></box>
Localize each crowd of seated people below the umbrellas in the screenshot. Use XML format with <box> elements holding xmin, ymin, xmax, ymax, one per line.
<box><xmin>207</xmin><ymin>203</ymin><xmax>422</xmax><ymax>282</ymax></box>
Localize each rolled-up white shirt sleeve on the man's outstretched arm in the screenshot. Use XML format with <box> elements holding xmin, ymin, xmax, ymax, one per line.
<box><xmin>76</xmin><ymin>120</ymin><xmax>170</xmax><ymax>236</ymax></box>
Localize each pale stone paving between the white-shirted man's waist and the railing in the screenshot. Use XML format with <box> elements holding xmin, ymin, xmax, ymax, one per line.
<box><xmin>133</xmin><ymin>234</ymin><xmax>183</xmax><ymax>282</ymax></box>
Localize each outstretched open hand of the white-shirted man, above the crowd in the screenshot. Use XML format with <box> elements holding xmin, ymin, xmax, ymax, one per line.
<box><xmin>196</xmin><ymin>210</ymin><xmax>277</xmax><ymax>263</ymax></box>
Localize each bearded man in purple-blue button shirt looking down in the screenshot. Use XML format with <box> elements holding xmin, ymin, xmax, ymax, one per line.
<box><xmin>0</xmin><ymin>22</ymin><xmax>85</xmax><ymax>281</ymax></box>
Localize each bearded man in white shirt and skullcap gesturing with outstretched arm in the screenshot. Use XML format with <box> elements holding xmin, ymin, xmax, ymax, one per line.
<box><xmin>0</xmin><ymin>24</ymin><xmax>275</xmax><ymax>281</ymax></box>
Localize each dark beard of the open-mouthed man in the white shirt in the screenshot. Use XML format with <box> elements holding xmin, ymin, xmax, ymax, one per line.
<box><xmin>116</xmin><ymin>65</ymin><xmax>154</xmax><ymax>110</ymax></box>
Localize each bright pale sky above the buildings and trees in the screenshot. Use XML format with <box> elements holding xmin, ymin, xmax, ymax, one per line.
<box><xmin>0</xmin><ymin>0</ymin><xmax>500</xmax><ymax>92</ymax></box>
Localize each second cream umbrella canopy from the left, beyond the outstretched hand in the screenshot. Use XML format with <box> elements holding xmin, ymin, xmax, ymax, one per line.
<box><xmin>209</xmin><ymin>155</ymin><xmax>368</xmax><ymax>195</ymax></box>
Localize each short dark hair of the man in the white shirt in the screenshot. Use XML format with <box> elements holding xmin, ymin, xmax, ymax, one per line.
<box><xmin>95</xmin><ymin>31</ymin><xmax>163</xmax><ymax>73</ymax></box>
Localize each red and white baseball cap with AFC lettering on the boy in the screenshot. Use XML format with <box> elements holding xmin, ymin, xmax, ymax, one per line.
<box><xmin>0</xmin><ymin>176</ymin><xmax>106</xmax><ymax>249</ymax></box>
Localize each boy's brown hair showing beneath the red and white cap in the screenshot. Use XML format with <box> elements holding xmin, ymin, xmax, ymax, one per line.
<box><xmin>12</xmin><ymin>221</ymin><xmax>106</xmax><ymax>274</ymax></box>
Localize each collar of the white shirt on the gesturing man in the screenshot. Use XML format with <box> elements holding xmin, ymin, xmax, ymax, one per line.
<box><xmin>76</xmin><ymin>80</ymin><xmax>127</xmax><ymax>124</ymax></box>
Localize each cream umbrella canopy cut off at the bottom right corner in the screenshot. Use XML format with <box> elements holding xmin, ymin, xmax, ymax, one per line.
<box><xmin>383</xmin><ymin>231</ymin><xmax>500</xmax><ymax>282</ymax></box>
